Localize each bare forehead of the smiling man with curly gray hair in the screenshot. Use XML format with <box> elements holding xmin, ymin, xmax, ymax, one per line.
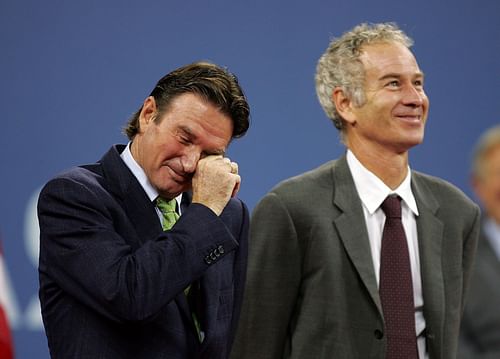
<box><xmin>359</xmin><ymin>42</ymin><xmax>421</xmax><ymax>75</ymax></box>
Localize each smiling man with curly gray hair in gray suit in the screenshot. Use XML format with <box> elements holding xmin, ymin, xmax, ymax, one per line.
<box><xmin>232</xmin><ymin>24</ymin><xmax>480</xmax><ymax>359</ymax></box>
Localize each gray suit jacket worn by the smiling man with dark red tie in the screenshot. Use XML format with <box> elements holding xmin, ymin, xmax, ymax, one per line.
<box><xmin>231</xmin><ymin>156</ymin><xmax>480</xmax><ymax>359</ymax></box>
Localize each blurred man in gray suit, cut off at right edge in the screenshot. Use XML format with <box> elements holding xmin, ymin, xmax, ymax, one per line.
<box><xmin>458</xmin><ymin>126</ymin><xmax>500</xmax><ymax>359</ymax></box>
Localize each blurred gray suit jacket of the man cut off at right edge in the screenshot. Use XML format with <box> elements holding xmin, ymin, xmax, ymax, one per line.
<box><xmin>458</xmin><ymin>224</ymin><xmax>500</xmax><ymax>359</ymax></box>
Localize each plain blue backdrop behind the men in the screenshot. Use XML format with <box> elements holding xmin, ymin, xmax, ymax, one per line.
<box><xmin>0</xmin><ymin>0</ymin><xmax>500</xmax><ymax>359</ymax></box>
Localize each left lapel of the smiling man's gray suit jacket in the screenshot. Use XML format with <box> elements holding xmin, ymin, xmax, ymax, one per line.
<box><xmin>333</xmin><ymin>156</ymin><xmax>382</xmax><ymax>313</ymax></box>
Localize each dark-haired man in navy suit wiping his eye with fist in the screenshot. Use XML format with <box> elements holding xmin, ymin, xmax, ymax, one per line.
<box><xmin>38</xmin><ymin>63</ymin><xmax>249</xmax><ymax>359</ymax></box>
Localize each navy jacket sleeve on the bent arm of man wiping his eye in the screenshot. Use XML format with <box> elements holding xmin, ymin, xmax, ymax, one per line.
<box><xmin>38</xmin><ymin>177</ymin><xmax>238</xmax><ymax>322</ymax></box>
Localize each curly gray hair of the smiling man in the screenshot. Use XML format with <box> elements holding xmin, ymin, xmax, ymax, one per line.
<box><xmin>315</xmin><ymin>23</ymin><xmax>413</xmax><ymax>136</ymax></box>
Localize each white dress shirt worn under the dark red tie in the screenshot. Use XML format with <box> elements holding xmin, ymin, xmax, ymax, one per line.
<box><xmin>347</xmin><ymin>150</ymin><xmax>428</xmax><ymax>359</ymax></box>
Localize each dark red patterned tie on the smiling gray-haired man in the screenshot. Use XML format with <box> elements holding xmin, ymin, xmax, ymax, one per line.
<box><xmin>379</xmin><ymin>196</ymin><xmax>418</xmax><ymax>359</ymax></box>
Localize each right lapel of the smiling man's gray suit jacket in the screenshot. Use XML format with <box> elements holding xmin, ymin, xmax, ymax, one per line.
<box><xmin>412</xmin><ymin>172</ymin><xmax>445</xmax><ymax>358</ymax></box>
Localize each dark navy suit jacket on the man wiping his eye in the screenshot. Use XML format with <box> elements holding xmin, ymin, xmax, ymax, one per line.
<box><xmin>38</xmin><ymin>145</ymin><xmax>248</xmax><ymax>359</ymax></box>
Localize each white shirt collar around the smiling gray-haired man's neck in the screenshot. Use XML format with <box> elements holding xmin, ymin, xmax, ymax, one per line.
<box><xmin>347</xmin><ymin>150</ymin><xmax>418</xmax><ymax>216</ymax></box>
